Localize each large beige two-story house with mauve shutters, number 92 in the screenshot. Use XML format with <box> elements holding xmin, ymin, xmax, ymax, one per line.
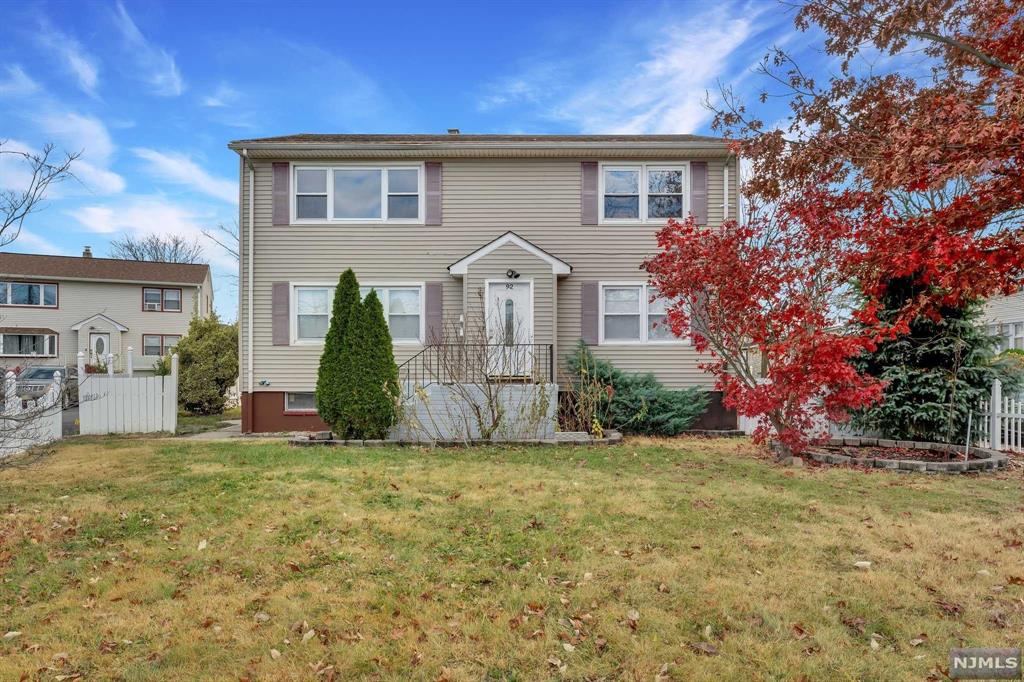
<box><xmin>228</xmin><ymin>131</ymin><xmax>738</xmax><ymax>431</ymax></box>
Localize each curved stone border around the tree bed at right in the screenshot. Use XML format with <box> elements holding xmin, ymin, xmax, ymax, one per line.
<box><xmin>807</xmin><ymin>438</ymin><xmax>1010</xmax><ymax>474</ymax></box>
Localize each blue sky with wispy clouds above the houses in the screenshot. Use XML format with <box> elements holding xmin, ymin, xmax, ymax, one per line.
<box><xmin>0</xmin><ymin>0</ymin><xmax>808</xmax><ymax>319</ymax></box>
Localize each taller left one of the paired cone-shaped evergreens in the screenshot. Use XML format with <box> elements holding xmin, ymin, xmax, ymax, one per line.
<box><xmin>316</xmin><ymin>268</ymin><xmax>359</xmax><ymax>438</ymax></box>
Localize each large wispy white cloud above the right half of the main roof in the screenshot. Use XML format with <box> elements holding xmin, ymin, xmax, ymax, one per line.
<box><xmin>477</xmin><ymin>3</ymin><xmax>772</xmax><ymax>134</ymax></box>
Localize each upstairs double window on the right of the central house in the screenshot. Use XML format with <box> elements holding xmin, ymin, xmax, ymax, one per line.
<box><xmin>600</xmin><ymin>164</ymin><xmax>689</xmax><ymax>223</ymax></box>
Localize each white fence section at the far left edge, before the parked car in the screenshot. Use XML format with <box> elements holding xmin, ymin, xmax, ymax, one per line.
<box><xmin>0</xmin><ymin>372</ymin><xmax>63</xmax><ymax>460</ymax></box>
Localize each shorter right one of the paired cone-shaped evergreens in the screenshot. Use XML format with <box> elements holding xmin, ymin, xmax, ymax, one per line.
<box><xmin>335</xmin><ymin>291</ymin><xmax>398</xmax><ymax>439</ymax></box>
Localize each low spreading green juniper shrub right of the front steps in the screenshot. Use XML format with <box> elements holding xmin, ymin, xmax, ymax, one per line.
<box><xmin>567</xmin><ymin>341</ymin><xmax>708</xmax><ymax>436</ymax></box>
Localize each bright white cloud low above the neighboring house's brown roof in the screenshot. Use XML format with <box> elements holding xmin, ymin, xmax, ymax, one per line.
<box><xmin>69</xmin><ymin>195</ymin><xmax>238</xmax><ymax>271</ymax></box>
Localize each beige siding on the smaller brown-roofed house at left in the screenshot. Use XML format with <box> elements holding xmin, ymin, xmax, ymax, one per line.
<box><xmin>0</xmin><ymin>278</ymin><xmax>200</xmax><ymax>370</ymax></box>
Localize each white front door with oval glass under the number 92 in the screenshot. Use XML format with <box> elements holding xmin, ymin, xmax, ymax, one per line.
<box><xmin>486</xmin><ymin>281</ymin><xmax>534</xmax><ymax>377</ymax></box>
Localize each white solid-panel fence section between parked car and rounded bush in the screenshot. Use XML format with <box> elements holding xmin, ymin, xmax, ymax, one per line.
<box><xmin>78</xmin><ymin>348</ymin><xmax>178</xmax><ymax>435</ymax></box>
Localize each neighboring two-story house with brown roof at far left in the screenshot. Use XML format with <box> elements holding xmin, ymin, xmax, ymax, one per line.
<box><xmin>0</xmin><ymin>247</ymin><xmax>213</xmax><ymax>372</ymax></box>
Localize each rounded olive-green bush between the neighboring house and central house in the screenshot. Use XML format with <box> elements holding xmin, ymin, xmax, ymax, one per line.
<box><xmin>174</xmin><ymin>314</ymin><xmax>239</xmax><ymax>415</ymax></box>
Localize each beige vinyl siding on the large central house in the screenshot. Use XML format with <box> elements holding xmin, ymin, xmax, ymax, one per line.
<box><xmin>239</xmin><ymin>155</ymin><xmax>737</xmax><ymax>391</ymax></box>
